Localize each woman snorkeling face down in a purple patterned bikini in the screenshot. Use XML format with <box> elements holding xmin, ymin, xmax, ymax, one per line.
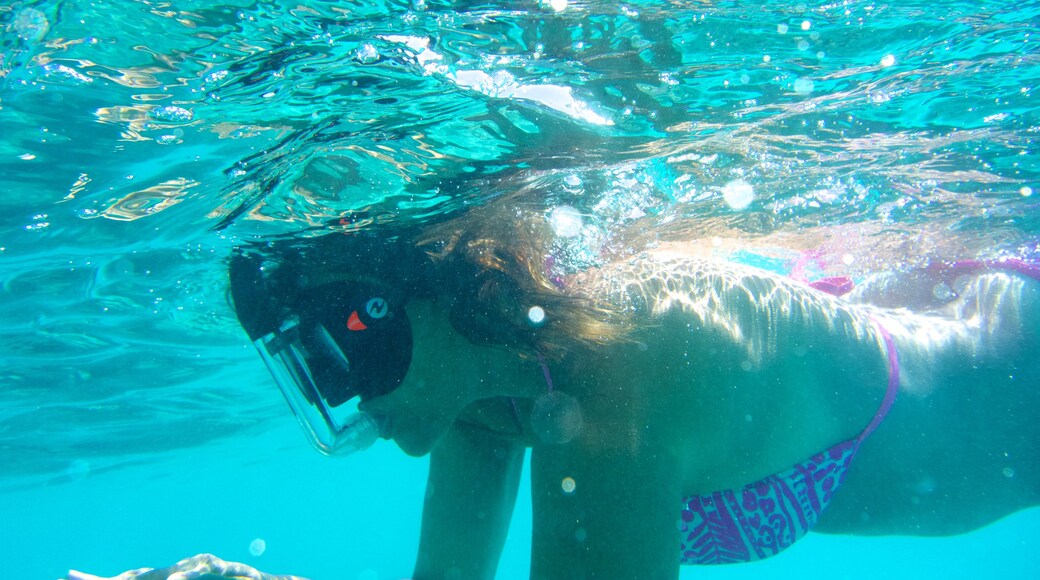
<box><xmin>70</xmin><ymin>193</ymin><xmax>1040</xmax><ymax>580</ymax></box>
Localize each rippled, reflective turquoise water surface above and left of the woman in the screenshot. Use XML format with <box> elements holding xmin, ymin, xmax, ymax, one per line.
<box><xmin>0</xmin><ymin>0</ymin><xmax>1040</xmax><ymax>482</ymax></box>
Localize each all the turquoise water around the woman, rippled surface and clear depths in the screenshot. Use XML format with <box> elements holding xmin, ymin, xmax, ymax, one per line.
<box><xmin>0</xmin><ymin>0</ymin><xmax>1040</xmax><ymax>579</ymax></box>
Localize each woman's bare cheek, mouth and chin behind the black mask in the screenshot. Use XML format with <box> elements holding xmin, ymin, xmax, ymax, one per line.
<box><xmin>361</xmin><ymin>299</ymin><xmax>545</xmax><ymax>456</ymax></box>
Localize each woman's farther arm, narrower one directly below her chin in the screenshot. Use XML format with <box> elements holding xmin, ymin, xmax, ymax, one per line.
<box><xmin>413</xmin><ymin>421</ymin><xmax>524</xmax><ymax>580</ymax></box>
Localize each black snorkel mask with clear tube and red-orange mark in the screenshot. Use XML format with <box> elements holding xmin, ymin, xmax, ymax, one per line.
<box><xmin>229</xmin><ymin>239</ymin><xmax>412</xmax><ymax>455</ymax></box>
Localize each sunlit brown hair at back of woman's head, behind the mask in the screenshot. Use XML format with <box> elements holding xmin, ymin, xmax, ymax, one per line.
<box><xmin>416</xmin><ymin>195</ymin><xmax>626</xmax><ymax>359</ymax></box>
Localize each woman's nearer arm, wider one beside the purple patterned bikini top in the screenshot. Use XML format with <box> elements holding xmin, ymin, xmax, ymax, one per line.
<box><xmin>530</xmin><ymin>355</ymin><xmax>683</xmax><ymax>580</ymax></box>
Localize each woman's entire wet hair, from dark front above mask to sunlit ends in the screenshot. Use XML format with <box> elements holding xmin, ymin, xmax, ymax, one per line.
<box><xmin>229</xmin><ymin>199</ymin><xmax>630</xmax><ymax>360</ymax></box>
